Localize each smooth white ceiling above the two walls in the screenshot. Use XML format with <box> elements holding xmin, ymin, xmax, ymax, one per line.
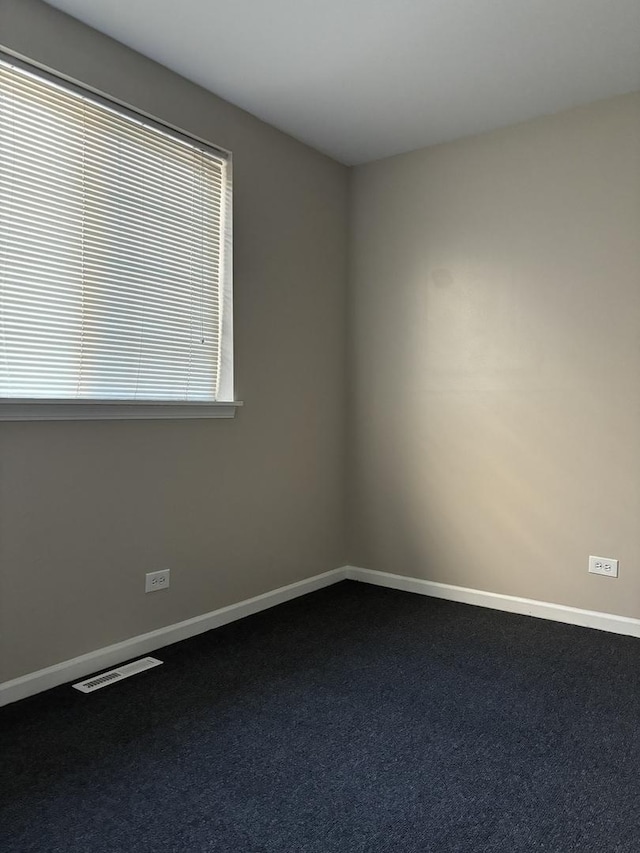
<box><xmin>45</xmin><ymin>0</ymin><xmax>640</xmax><ymax>164</ymax></box>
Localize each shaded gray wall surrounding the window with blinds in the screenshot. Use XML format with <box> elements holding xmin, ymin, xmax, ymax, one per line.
<box><xmin>0</xmin><ymin>0</ymin><xmax>347</xmax><ymax>681</ymax></box>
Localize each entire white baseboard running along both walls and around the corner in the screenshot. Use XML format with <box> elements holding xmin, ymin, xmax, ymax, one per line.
<box><xmin>0</xmin><ymin>566</ymin><xmax>640</xmax><ymax>707</ymax></box>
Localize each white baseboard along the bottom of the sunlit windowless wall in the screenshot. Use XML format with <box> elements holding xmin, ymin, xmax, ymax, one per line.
<box><xmin>344</xmin><ymin>566</ymin><xmax>640</xmax><ymax>637</ymax></box>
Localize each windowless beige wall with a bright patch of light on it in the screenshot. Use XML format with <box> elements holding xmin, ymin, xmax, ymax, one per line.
<box><xmin>348</xmin><ymin>94</ymin><xmax>640</xmax><ymax>617</ymax></box>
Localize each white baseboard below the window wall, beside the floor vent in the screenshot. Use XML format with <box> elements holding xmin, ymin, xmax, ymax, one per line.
<box><xmin>0</xmin><ymin>568</ymin><xmax>345</xmax><ymax>707</ymax></box>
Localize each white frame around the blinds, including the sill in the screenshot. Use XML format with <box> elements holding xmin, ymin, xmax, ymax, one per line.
<box><xmin>0</xmin><ymin>47</ymin><xmax>242</xmax><ymax>421</ymax></box>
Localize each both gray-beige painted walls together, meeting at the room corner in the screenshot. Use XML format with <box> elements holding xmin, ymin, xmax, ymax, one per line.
<box><xmin>0</xmin><ymin>0</ymin><xmax>640</xmax><ymax>681</ymax></box>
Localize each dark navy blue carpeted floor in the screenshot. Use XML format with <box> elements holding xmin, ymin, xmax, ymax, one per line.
<box><xmin>0</xmin><ymin>582</ymin><xmax>640</xmax><ymax>853</ymax></box>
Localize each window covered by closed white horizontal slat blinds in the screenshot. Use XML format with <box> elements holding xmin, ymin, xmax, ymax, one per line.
<box><xmin>0</xmin><ymin>53</ymin><xmax>233</xmax><ymax>419</ymax></box>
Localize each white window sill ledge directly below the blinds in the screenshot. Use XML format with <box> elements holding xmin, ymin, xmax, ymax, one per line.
<box><xmin>0</xmin><ymin>400</ymin><xmax>243</xmax><ymax>421</ymax></box>
